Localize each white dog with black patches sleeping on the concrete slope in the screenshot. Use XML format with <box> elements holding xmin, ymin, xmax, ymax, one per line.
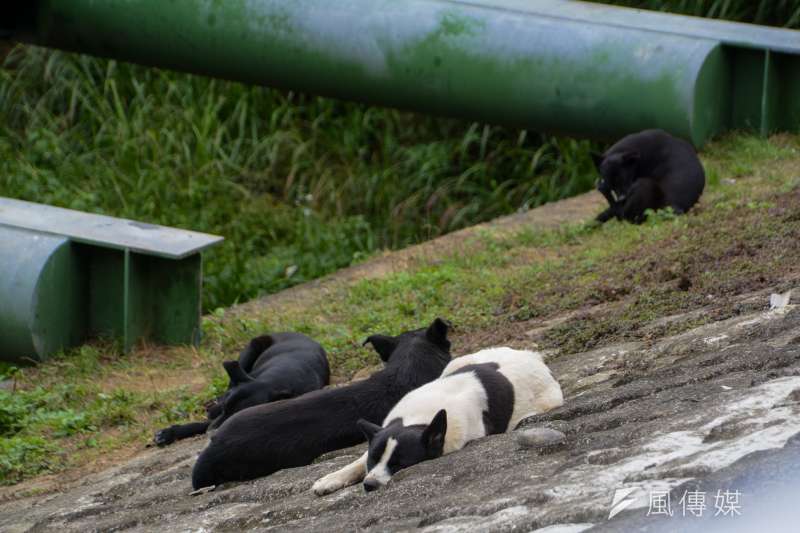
<box><xmin>312</xmin><ymin>348</ymin><xmax>564</xmax><ymax>496</ymax></box>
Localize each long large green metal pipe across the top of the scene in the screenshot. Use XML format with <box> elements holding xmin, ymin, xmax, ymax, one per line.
<box><xmin>10</xmin><ymin>0</ymin><xmax>800</xmax><ymax>144</ymax></box>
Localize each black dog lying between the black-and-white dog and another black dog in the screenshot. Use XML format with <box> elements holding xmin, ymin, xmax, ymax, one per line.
<box><xmin>192</xmin><ymin>318</ymin><xmax>450</xmax><ymax>489</ymax></box>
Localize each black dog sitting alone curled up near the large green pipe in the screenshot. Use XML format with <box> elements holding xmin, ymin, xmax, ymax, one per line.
<box><xmin>593</xmin><ymin>130</ymin><xmax>706</xmax><ymax>224</ymax></box>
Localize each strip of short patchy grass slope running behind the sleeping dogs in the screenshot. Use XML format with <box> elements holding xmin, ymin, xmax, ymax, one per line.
<box><xmin>0</xmin><ymin>131</ymin><xmax>800</xmax><ymax>483</ymax></box>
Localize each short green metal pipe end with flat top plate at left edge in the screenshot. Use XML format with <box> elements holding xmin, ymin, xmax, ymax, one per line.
<box><xmin>0</xmin><ymin>198</ymin><xmax>222</xmax><ymax>360</ymax></box>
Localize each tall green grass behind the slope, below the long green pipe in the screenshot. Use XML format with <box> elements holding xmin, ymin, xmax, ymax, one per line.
<box><xmin>0</xmin><ymin>47</ymin><xmax>592</xmax><ymax>308</ymax></box>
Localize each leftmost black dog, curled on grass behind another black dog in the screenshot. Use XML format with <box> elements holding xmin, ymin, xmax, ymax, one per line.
<box><xmin>154</xmin><ymin>333</ymin><xmax>330</xmax><ymax>446</ymax></box>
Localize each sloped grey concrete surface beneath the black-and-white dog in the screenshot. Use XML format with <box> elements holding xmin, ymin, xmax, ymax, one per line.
<box><xmin>0</xmin><ymin>293</ymin><xmax>800</xmax><ymax>533</ymax></box>
